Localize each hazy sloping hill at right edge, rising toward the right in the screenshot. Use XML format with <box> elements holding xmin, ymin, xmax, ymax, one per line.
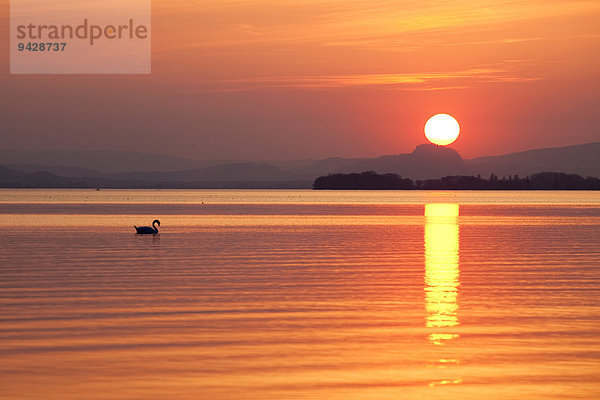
<box><xmin>465</xmin><ymin>142</ymin><xmax>600</xmax><ymax>176</ymax></box>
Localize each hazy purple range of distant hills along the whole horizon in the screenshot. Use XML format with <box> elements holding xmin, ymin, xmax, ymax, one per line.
<box><xmin>0</xmin><ymin>142</ymin><xmax>600</xmax><ymax>188</ymax></box>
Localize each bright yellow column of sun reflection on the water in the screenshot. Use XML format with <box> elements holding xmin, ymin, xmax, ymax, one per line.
<box><xmin>425</xmin><ymin>204</ymin><xmax>459</xmax><ymax>345</ymax></box>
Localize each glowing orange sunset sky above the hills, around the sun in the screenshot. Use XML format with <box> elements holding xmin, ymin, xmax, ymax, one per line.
<box><xmin>0</xmin><ymin>0</ymin><xmax>600</xmax><ymax>160</ymax></box>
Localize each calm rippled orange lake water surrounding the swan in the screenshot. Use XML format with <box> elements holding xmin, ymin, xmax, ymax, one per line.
<box><xmin>0</xmin><ymin>190</ymin><xmax>600</xmax><ymax>400</ymax></box>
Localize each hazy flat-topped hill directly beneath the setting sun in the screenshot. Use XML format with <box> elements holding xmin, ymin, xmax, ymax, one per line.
<box><xmin>336</xmin><ymin>144</ymin><xmax>466</xmax><ymax>179</ymax></box>
